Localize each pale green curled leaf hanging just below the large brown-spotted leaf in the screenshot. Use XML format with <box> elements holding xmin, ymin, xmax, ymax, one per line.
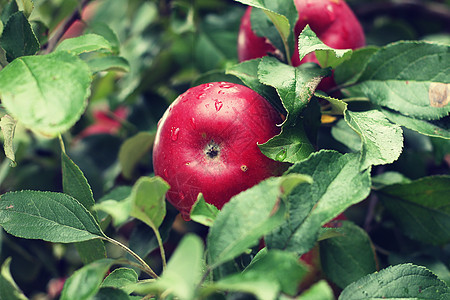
<box><xmin>345</xmin><ymin>110</ymin><xmax>403</xmax><ymax>170</ymax></box>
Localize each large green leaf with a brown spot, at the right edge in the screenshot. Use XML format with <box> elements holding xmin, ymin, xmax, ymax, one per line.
<box><xmin>357</xmin><ymin>41</ymin><xmax>450</xmax><ymax>120</ymax></box>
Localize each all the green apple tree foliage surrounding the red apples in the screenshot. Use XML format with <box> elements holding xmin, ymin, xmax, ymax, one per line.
<box><xmin>0</xmin><ymin>0</ymin><xmax>450</xmax><ymax>300</ymax></box>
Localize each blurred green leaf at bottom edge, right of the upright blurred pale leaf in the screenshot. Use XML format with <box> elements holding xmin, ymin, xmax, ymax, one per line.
<box><xmin>203</xmin><ymin>250</ymin><xmax>307</xmax><ymax>300</ymax></box>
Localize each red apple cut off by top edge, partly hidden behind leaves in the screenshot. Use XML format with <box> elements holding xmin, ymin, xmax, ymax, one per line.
<box><xmin>238</xmin><ymin>0</ymin><xmax>365</xmax><ymax>91</ymax></box>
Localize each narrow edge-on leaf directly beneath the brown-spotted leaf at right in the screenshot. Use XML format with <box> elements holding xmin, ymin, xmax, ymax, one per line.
<box><xmin>381</xmin><ymin>109</ymin><xmax>450</xmax><ymax>139</ymax></box>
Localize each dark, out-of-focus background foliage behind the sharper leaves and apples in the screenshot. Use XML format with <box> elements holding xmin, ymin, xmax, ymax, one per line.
<box><xmin>0</xmin><ymin>0</ymin><xmax>450</xmax><ymax>299</ymax></box>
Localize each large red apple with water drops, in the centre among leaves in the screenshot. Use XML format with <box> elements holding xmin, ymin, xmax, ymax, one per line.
<box><xmin>153</xmin><ymin>82</ymin><xmax>288</xmax><ymax>220</ymax></box>
